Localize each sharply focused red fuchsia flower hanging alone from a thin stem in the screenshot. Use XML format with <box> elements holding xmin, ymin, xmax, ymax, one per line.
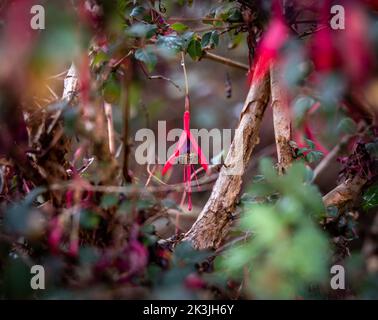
<box><xmin>162</xmin><ymin>96</ymin><xmax>208</xmax><ymax>210</ymax></box>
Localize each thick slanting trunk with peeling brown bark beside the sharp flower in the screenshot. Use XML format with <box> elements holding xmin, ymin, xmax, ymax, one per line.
<box><xmin>183</xmin><ymin>75</ymin><xmax>270</xmax><ymax>249</ymax></box>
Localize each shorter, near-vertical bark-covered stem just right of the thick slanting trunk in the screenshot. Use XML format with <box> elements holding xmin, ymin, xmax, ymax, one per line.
<box><xmin>270</xmin><ymin>66</ymin><xmax>293</xmax><ymax>173</ymax></box>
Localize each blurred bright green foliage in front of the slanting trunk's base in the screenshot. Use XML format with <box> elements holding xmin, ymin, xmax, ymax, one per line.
<box><xmin>217</xmin><ymin>159</ymin><xmax>330</xmax><ymax>299</ymax></box>
